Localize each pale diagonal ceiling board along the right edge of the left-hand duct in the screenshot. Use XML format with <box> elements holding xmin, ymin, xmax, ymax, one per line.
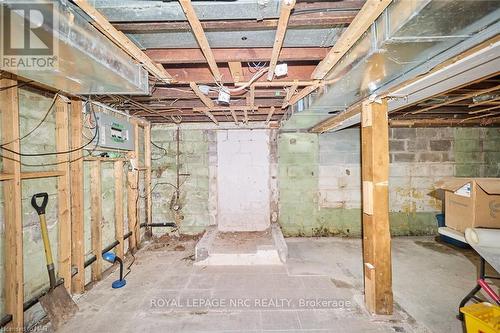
<box><xmin>73</xmin><ymin>0</ymin><xmax>174</xmax><ymax>83</ymax></box>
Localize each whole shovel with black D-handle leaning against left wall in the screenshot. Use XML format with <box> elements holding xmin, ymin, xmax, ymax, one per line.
<box><xmin>31</xmin><ymin>193</ymin><xmax>78</xmax><ymax>330</ymax></box>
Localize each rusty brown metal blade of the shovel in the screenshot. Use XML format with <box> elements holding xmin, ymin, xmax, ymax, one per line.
<box><xmin>40</xmin><ymin>284</ymin><xmax>78</xmax><ymax>331</ymax></box>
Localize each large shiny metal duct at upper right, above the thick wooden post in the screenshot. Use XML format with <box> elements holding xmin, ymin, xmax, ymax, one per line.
<box><xmin>284</xmin><ymin>0</ymin><xmax>500</xmax><ymax>128</ymax></box>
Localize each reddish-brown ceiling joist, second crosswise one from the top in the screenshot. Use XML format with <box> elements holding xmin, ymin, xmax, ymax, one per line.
<box><xmin>144</xmin><ymin>47</ymin><xmax>329</xmax><ymax>64</ymax></box>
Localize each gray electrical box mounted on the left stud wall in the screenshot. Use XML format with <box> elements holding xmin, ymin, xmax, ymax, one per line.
<box><xmin>94</xmin><ymin>112</ymin><xmax>135</xmax><ymax>150</ymax></box>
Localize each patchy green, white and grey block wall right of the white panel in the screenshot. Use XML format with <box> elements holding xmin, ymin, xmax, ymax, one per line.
<box><xmin>278</xmin><ymin>128</ymin><xmax>500</xmax><ymax>236</ymax></box>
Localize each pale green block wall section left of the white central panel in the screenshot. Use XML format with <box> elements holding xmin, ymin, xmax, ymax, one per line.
<box><xmin>151</xmin><ymin>125</ymin><xmax>211</xmax><ymax>235</ymax></box>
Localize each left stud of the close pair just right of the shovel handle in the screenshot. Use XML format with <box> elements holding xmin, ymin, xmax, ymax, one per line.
<box><xmin>56</xmin><ymin>97</ymin><xmax>72</xmax><ymax>293</ymax></box>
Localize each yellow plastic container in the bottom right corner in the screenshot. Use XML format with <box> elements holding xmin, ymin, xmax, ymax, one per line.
<box><xmin>460</xmin><ymin>303</ymin><xmax>500</xmax><ymax>333</ymax></box>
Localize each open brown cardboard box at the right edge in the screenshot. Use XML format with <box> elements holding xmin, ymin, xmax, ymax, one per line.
<box><xmin>437</xmin><ymin>178</ymin><xmax>500</xmax><ymax>232</ymax></box>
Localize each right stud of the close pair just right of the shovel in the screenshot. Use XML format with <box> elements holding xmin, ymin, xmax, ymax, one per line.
<box><xmin>70</xmin><ymin>99</ymin><xmax>85</xmax><ymax>294</ymax></box>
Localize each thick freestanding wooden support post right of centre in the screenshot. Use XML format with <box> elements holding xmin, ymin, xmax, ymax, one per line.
<box><xmin>361</xmin><ymin>100</ymin><xmax>393</xmax><ymax>314</ymax></box>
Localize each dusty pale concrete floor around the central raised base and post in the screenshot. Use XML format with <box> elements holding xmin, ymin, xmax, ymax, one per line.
<box><xmin>52</xmin><ymin>237</ymin><xmax>494</xmax><ymax>333</ymax></box>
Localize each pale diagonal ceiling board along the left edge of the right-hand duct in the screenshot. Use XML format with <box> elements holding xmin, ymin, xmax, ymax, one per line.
<box><xmin>311</xmin><ymin>0</ymin><xmax>392</xmax><ymax>80</ymax></box>
